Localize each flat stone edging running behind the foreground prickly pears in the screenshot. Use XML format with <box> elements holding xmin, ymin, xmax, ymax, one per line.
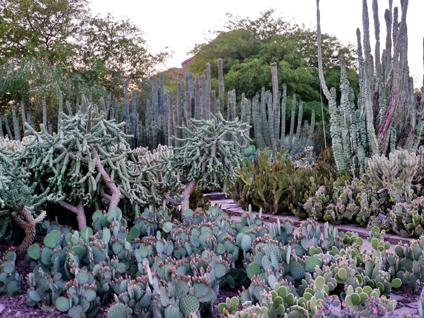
<box><xmin>203</xmin><ymin>192</ymin><xmax>413</xmax><ymax>245</ymax></box>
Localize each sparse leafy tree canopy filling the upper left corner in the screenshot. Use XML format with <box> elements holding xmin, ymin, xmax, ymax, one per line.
<box><xmin>0</xmin><ymin>0</ymin><xmax>170</xmax><ymax>123</ymax></box>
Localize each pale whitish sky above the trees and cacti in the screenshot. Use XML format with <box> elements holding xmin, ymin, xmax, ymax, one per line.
<box><xmin>91</xmin><ymin>0</ymin><xmax>424</xmax><ymax>87</ymax></box>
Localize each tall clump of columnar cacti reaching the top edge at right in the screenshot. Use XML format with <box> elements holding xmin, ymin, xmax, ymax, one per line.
<box><xmin>317</xmin><ymin>0</ymin><xmax>424</xmax><ymax>177</ymax></box>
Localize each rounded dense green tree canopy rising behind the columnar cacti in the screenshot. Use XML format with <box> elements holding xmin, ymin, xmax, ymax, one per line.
<box><xmin>189</xmin><ymin>9</ymin><xmax>359</xmax><ymax>119</ymax></box>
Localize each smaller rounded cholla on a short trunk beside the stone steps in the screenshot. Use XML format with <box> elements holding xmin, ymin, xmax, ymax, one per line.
<box><xmin>165</xmin><ymin>113</ymin><xmax>250</xmax><ymax>211</ymax></box>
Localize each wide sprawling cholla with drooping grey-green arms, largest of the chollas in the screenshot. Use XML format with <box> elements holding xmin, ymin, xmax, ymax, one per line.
<box><xmin>12</xmin><ymin>105</ymin><xmax>159</xmax><ymax>230</ymax></box>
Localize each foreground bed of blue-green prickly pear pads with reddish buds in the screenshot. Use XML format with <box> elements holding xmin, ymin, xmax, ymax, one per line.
<box><xmin>0</xmin><ymin>207</ymin><xmax>424</xmax><ymax>318</ymax></box>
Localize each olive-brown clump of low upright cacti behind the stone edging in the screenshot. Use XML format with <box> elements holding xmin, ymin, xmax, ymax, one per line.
<box><xmin>229</xmin><ymin>150</ymin><xmax>344</xmax><ymax>218</ymax></box>
